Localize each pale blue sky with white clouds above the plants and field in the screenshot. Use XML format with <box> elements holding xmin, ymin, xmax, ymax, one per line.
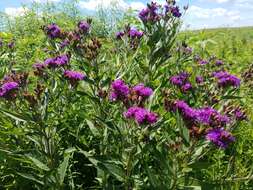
<box><xmin>0</xmin><ymin>0</ymin><xmax>253</xmax><ymax>29</ymax></box>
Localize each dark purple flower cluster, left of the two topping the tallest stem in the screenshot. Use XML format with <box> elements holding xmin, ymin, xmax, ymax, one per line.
<box><xmin>139</xmin><ymin>2</ymin><xmax>160</xmax><ymax>23</ymax></box>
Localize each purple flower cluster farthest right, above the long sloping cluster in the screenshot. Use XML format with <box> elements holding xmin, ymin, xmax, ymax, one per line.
<box><xmin>213</xmin><ymin>71</ymin><xmax>241</xmax><ymax>87</ymax></box>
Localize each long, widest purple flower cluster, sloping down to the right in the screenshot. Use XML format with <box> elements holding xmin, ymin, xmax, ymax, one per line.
<box><xmin>173</xmin><ymin>100</ymin><xmax>229</xmax><ymax>127</ymax></box>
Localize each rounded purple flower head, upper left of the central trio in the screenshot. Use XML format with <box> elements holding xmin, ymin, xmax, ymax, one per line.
<box><xmin>110</xmin><ymin>79</ymin><xmax>130</xmax><ymax>101</ymax></box>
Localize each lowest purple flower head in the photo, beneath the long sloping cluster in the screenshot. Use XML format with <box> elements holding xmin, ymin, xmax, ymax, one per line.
<box><xmin>206</xmin><ymin>128</ymin><xmax>235</xmax><ymax>149</ymax></box>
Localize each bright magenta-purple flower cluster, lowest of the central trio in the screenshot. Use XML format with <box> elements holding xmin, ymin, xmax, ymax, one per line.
<box><xmin>124</xmin><ymin>107</ymin><xmax>158</xmax><ymax>125</ymax></box>
